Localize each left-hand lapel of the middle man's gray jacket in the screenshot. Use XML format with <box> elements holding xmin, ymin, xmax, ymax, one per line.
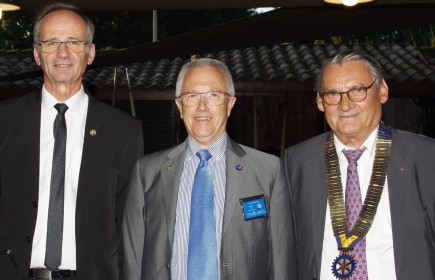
<box><xmin>160</xmin><ymin>141</ymin><xmax>187</xmax><ymax>247</ymax></box>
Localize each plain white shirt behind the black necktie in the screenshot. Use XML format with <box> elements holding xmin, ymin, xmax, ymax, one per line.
<box><xmin>30</xmin><ymin>86</ymin><xmax>89</xmax><ymax>270</ymax></box>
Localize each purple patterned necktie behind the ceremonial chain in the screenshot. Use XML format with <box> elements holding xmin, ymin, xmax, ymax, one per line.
<box><xmin>343</xmin><ymin>147</ymin><xmax>368</xmax><ymax>280</ymax></box>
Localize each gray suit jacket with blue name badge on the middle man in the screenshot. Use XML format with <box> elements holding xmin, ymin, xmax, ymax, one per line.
<box><xmin>123</xmin><ymin>139</ymin><xmax>296</xmax><ymax>280</ymax></box>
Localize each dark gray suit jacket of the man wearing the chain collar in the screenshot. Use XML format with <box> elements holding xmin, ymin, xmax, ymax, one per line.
<box><xmin>284</xmin><ymin>129</ymin><xmax>435</xmax><ymax>280</ymax></box>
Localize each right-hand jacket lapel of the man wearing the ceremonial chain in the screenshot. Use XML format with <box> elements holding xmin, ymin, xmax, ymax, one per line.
<box><xmin>387</xmin><ymin>130</ymin><xmax>413</xmax><ymax>279</ymax></box>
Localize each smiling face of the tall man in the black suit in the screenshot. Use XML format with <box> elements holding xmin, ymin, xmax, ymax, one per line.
<box><xmin>33</xmin><ymin>11</ymin><xmax>95</xmax><ymax>97</ymax></box>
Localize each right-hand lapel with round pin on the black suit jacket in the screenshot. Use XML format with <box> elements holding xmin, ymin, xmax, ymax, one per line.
<box><xmin>77</xmin><ymin>94</ymin><xmax>104</xmax><ymax>209</ymax></box>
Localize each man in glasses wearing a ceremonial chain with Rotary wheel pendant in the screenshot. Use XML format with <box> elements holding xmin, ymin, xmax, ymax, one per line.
<box><xmin>284</xmin><ymin>51</ymin><xmax>435</xmax><ymax>280</ymax></box>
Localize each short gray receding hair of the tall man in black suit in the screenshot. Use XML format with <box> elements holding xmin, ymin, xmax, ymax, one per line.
<box><xmin>33</xmin><ymin>2</ymin><xmax>95</xmax><ymax>53</ymax></box>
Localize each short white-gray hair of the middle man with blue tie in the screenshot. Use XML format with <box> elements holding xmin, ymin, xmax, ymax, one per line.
<box><xmin>175</xmin><ymin>58</ymin><xmax>235</xmax><ymax>98</ymax></box>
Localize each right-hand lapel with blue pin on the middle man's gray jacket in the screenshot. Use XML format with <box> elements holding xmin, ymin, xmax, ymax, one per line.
<box><xmin>222</xmin><ymin>137</ymin><xmax>250</xmax><ymax>236</ymax></box>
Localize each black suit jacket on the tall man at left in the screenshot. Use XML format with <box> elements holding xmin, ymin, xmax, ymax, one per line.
<box><xmin>0</xmin><ymin>92</ymin><xmax>143</xmax><ymax>280</ymax></box>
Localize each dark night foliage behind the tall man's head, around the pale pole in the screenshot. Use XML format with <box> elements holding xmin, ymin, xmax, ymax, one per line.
<box><xmin>0</xmin><ymin>9</ymin><xmax>256</xmax><ymax>49</ymax></box>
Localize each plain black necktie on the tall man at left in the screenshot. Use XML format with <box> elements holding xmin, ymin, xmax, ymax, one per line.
<box><xmin>44</xmin><ymin>103</ymin><xmax>68</xmax><ymax>271</ymax></box>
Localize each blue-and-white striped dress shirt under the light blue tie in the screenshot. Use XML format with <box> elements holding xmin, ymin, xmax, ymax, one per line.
<box><xmin>171</xmin><ymin>133</ymin><xmax>228</xmax><ymax>280</ymax></box>
